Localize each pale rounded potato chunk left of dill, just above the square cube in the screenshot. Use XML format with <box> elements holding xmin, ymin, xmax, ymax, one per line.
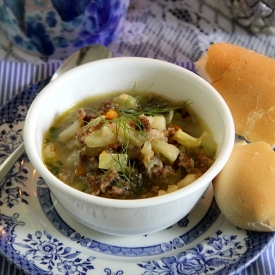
<box><xmin>84</xmin><ymin>125</ymin><xmax>116</xmax><ymax>148</ymax></box>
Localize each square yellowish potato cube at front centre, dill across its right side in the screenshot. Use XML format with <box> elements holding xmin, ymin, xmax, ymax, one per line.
<box><xmin>98</xmin><ymin>151</ymin><xmax>128</xmax><ymax>171</ymax></box>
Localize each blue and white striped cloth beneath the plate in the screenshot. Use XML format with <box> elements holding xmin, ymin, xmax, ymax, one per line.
<box><xmin>0</xmin><ymin>61</ymin><xmax>275</xmax><ymax>275</ymax></box>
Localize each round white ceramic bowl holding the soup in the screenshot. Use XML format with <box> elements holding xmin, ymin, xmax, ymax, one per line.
<box><xmin>24</xmin><ymin>57</ymin><xmax>235</xmax><ymax>235</ymax></box>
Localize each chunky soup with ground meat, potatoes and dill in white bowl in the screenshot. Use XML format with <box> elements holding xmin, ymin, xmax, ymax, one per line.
<box><xmin>42</xmin><ymin>91</ymin><xmax>216</xmax><ymax>199</ymax></box>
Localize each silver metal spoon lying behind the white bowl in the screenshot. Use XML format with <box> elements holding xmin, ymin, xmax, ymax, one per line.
<box><xmin>0</xmin><ymin>44</ymin><xmax>113</xmax><ymax>183</ymax></box>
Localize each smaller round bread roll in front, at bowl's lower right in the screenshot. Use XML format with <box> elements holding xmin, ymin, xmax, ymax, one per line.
<box><xmin>213</xmin><ymin>142</ymin><xmax>275</xmax><ymax>231</ymax></box>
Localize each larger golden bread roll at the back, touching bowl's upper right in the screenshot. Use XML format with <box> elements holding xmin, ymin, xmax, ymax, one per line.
<box><xmin>195</xmin><ymin>43</ymin><xmax>275</xmax><ymax>147</ymax></box>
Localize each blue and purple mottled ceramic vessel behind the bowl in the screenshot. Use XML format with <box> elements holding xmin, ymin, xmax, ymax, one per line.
<box><xmin>0</xmin><ymin>0</ymin><xmax>130</xmax><ymax>58</ymax></box>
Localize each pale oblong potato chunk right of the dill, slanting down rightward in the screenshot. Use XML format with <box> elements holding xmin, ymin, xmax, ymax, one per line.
<box><xmin>150</xmin><ymin>139</ymin><xmax>180</xmax><ymax>164</ymax></box>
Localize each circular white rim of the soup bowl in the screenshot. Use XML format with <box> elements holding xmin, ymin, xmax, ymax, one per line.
<box><xmin>23</xmin><ymin>57</ymin><xmax>235</xmax><ymax>208</ymax></box>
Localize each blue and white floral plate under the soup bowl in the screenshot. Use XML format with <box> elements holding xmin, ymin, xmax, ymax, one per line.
<box><xmin>0</xmin><ymin>80</ymin><xmax>273</xmax><ymax>275</ymax></box>
